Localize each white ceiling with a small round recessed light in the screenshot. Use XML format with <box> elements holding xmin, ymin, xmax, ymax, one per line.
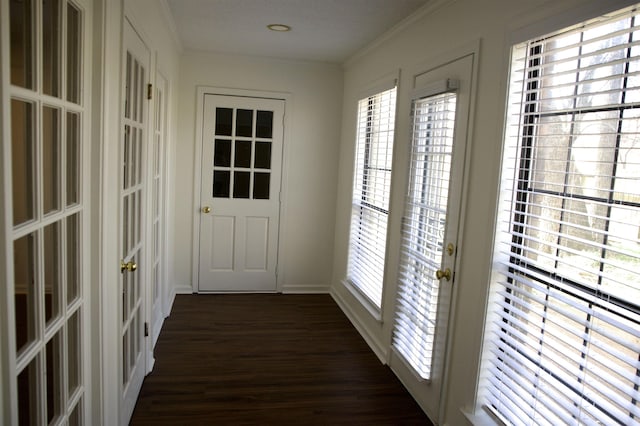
<box><xmin>167</xmin><ymin>0</ymin><xmax>429</xmax><ymax>63</ymax></box>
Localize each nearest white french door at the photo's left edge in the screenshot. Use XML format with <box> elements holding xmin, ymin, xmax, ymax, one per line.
<box><xmin>0</xmin><ymin>0</ymin><xmax>92</xmax><ymax>425</ymax></box>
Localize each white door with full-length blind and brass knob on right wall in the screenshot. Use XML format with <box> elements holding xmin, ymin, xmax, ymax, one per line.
<box><xmin>390</xmin><ymin>55</ymin><xmax>474</xmax><ymax>423</ymax></box>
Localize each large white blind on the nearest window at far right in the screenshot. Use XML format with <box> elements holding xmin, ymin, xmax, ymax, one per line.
<box><xmin>481</xmin><ymin>4</ymin><xmax>640</xmax><ymax>425</ymax></box>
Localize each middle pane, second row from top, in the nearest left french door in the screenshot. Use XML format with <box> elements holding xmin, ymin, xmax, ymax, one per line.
<box><xmin>42</xmin><ymin>106</ymin><xmax>61</xmax><ymax>214</ymax></box>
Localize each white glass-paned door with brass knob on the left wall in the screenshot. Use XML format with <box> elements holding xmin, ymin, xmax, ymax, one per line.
<box><xmin>119</xmin><ymin>20</ymin><xmax>151</xmax><ymax>424</ymax></box>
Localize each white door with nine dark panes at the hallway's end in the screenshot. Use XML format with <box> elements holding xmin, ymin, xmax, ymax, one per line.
<box><xmin>198</xmin><ymin>94</ymin><xmax>284</xmax><ymax>292</ymax></box>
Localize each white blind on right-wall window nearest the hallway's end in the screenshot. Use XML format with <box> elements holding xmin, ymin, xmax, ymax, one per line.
<box><xmin>347</xmin><ymin>87</ymin><xmax>396</xmax><ymax>308</ymax></box>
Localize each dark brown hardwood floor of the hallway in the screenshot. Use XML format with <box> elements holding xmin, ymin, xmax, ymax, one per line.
<box><xmin>131</xmin><ymin>294</ymin><xmax>431</xmax><ymax>425</ymax></box>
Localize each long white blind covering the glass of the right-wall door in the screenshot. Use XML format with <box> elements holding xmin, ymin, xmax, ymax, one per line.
<box><xmin>393</xmin><ymin>93</ymin><xmax>456</xmax><ymax>380</ymax></box>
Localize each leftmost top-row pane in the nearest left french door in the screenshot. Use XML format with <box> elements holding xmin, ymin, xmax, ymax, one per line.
<box><xmin>9</xmin><ymin>0</ymin><xmax>35</xmax><ymax>89</ymax></box>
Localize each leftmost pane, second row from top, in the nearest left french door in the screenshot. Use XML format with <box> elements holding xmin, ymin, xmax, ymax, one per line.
<box><xmin>11</xmin><ymin>99</ymin><xmax>37</xmax><ymax>225</ymax></box>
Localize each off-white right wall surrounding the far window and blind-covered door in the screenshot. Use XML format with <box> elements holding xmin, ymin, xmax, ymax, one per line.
<box><xmin>332</xmin><ymin>0</ymin><xmax>636</xmax><ymax>425</ymax></box>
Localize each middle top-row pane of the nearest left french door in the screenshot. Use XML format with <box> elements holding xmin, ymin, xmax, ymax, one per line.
<box><xmin>42</xmin><ymin>0</ymin><xmax>61</xmax><ymax>97</ymax></box>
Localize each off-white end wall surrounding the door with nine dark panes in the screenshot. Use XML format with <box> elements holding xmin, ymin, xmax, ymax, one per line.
<box><xmin>173</xmin><ymin>52</ymin><xmax>342</xmax><ymax>292</ymax></box>
